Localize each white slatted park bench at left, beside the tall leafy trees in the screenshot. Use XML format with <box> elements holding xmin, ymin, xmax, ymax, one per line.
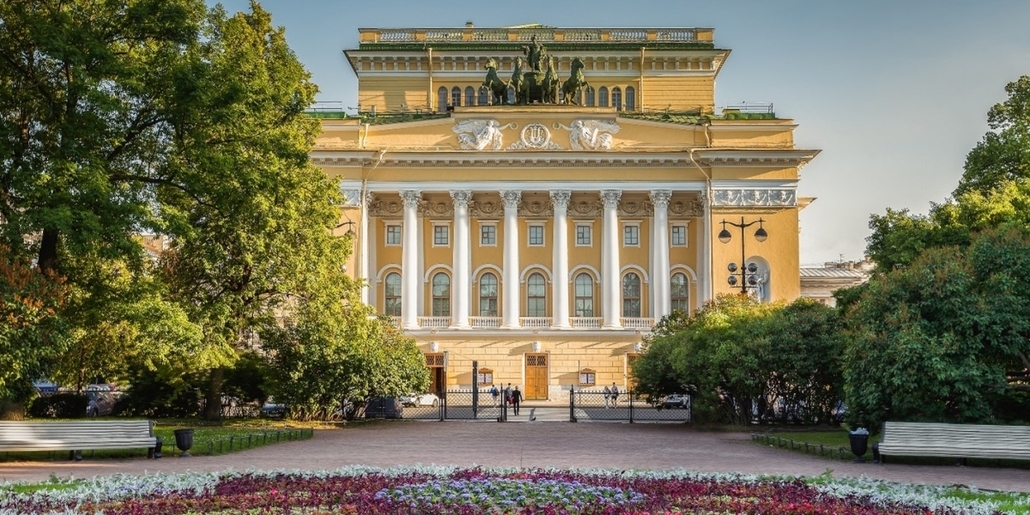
<box><xmin>0</xmin><ymin>420</ymin><xmax>157</xmax><ymax>460</ymax></box>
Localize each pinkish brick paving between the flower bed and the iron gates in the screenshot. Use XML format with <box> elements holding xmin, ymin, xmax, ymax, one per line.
<box><xmin>0</xmin><ymin>420</ymin><xmax>1030</xmax><ymax>492</ymax></box>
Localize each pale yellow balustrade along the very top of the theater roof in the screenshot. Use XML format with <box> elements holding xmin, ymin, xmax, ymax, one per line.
<box><xmin>359</xmin><ymin>27</ymin><xmax>715</xmax><ymax>43</ymax></box>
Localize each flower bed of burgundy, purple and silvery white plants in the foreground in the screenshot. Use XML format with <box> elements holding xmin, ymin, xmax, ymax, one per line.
<box><xmin>0</xmin><ymin>468</ymin><xmax>1013</xmax><ymax>515</ymax></box>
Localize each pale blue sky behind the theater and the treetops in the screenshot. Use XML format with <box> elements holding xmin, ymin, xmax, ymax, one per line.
<box><xmin>209</xmin><ymin>0</ymin><xmax>1030</xmax><ymax>264</ymax></box>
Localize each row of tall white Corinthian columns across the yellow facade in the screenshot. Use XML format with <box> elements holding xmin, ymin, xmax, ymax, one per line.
<box><xmin>383</xmin><ymin>190</ymin><xmax>673</xmax><ymax>330</ymax></box>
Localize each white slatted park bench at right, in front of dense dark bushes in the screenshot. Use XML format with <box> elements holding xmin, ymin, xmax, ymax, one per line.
<box><xmin>872</xmin><ymin>422</ymin><xmax>1030</xmax><ymax>464</ymax></box>
